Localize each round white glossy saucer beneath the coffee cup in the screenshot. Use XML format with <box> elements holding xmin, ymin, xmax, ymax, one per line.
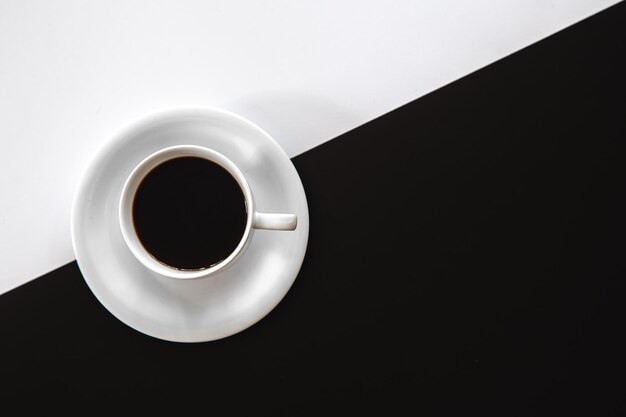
<box><xmin>72</xmin><ymin>109</ymin><xmax>309</xmax><ymax>342</ymax></box>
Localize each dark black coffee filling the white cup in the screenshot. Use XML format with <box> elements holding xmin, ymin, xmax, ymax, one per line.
<box><xmin>133</xmin><ymin>157</ymin><xmax>247</xmax><ymax>270</ymax></box>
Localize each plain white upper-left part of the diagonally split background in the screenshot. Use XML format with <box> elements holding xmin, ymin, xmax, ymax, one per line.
<box><xmin>0</xmin><ymin>0</ymin><xmax>617</xmax><ymax>293</ymax></box>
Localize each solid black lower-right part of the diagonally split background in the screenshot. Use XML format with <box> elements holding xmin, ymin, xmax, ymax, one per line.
<box><xmin>0</xmin><ymin>4</ymin><xmax>626</xmax><ymax>416</ymax></box>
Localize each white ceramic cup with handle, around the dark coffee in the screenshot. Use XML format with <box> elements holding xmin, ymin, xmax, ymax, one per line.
<box><xmin>119</xmin><ymin>145</ymin><xmax>298</xmax><ymax>279</ymax></box>
